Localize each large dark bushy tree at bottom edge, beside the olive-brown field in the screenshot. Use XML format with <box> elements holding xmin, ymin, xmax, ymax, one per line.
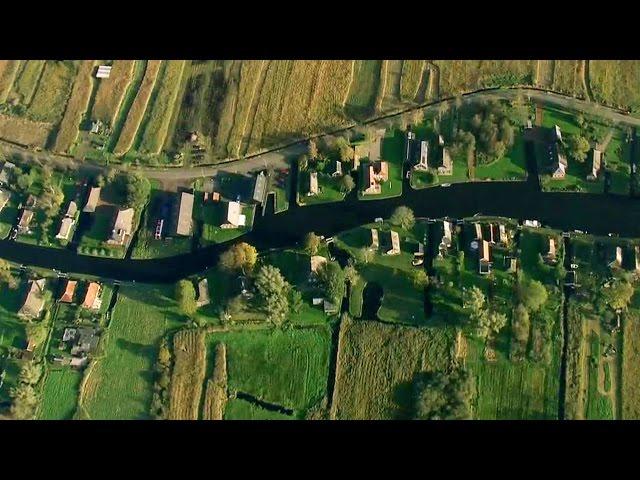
<box><xmin>413</xmin><ymin>368</ymin><xmax>475</xmax><ymax>420</ymax></box>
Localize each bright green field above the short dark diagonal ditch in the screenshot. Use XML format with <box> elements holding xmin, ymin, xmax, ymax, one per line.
<box><xmin>209</xmin><ymin>326</ymin><xmax>331</xmax><ymax>418</ymax></box>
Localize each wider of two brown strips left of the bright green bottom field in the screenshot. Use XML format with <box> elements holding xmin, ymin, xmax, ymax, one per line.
<box><xmin>168</xmin><ymin>330</ymin><xmax>206</xmax><ymax>420</ymax></box>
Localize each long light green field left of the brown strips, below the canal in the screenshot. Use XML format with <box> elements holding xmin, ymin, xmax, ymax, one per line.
<box><xmin>79</xmin><ymin>285</ymin><xmax>184</xmax><ymax>419</ymax></box>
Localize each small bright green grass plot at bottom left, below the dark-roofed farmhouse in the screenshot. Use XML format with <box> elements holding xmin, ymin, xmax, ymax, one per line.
<box><xmin>38</xmin><ymin>368</ymin><xmax>82</xmax><ymax>420</ymax></box>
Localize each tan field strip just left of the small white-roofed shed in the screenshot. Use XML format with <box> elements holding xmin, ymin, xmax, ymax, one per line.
<box><xmin>54</xmin><ymin>60</ymin><xmax>96</xmax><ymax>152</ymax></box>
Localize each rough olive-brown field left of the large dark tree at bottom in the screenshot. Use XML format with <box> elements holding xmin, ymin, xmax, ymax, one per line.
<box><xmin>332</xmin><ymin>320</ymin><xmax>454</xmax><ymax>420</ymax></box>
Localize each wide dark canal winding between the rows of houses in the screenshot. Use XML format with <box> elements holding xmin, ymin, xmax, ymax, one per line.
<box><xmin>0</xmin><ymin>144</ymin><xmax>640</xmax><ymax>282</ymax></box>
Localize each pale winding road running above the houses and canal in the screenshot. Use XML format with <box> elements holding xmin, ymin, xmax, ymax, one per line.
<box><xmin>0</xmin><ymin>88</ymin><xmax>640</xmax><ymax>186</ymax></box>
